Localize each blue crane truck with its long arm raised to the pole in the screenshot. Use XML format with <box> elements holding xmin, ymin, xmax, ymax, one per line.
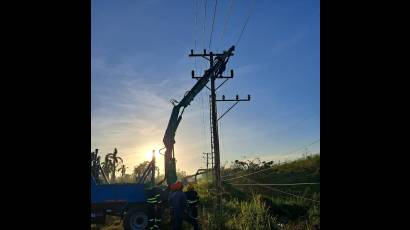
<box><xmin>91</xmin><ymin>46</ymin><xmax>235</xmax><ymax>230</ymax></box>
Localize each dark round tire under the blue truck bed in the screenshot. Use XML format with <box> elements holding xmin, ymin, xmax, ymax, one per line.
<box><xmin>123</xmin><ymin>208</ymin><xmax>149</xmax><ymax>230</ymax></box>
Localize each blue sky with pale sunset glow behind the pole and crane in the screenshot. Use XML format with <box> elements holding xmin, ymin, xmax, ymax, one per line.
<box><xmin>91</xmin><ymin>0</ymin><xmax>320</xmax><ymax>174</ymax></box>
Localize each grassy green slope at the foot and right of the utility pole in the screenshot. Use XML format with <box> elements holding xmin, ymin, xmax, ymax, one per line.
<box><xmin>198</xmin><ymin>154</ymin><xmax>320</xmax><ymax>229</ymax></box>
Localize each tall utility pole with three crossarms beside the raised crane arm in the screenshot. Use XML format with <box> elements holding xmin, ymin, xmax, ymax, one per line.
<box><xmin>189</xmin><ymin>46</ymin><xmax>250</xmax><ymax>215</ymax></box>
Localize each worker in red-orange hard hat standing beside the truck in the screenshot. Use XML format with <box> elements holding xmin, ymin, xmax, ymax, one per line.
<box><xmin>169</xmin><ymin>181</ymin><xmax>199</xmax><ymax>230</ymax></box>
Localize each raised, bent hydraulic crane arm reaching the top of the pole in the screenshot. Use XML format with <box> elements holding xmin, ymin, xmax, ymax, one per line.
<box><xmin>163</xmin><ymin>46</ymin><xmax>235</xmax><ymax>184</ymax></box>
